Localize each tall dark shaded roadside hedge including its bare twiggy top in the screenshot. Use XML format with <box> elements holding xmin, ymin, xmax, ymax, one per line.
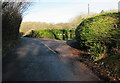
<box><xmin>2</xmin><ymin>0</ymin><xmax>30</xmax><ymax>55</ymax></box>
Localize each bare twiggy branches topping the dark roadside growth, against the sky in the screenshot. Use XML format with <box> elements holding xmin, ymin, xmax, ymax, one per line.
<box><xmin>2</xmin><ymin>0</ymin><xmax>31</xmax><ymax>15</ymax></box>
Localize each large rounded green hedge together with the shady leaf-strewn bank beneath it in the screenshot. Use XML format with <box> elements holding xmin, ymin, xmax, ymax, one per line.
<box><xmin>75</xmin><ymin>12</ymin><xmax>120</xmax><ymax>80</ymax></box>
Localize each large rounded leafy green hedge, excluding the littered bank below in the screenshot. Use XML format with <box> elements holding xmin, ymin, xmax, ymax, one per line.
<box><xmin>75</xmin><ymin>13</ymin><xmax>120</xmax><ymax>61</ymax></box>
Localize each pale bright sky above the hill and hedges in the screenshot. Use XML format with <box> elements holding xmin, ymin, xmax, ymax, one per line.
<box><xmin>23</xmin><ymin>0</ymin><xmax>120</xmax><ymax>23</ymax></box>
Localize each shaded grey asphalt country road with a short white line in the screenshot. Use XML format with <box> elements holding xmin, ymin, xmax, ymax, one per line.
<box><xmin>2</xmin><ymin>38</ymin><xmax>100</xmax><ymax>81</ymax></box>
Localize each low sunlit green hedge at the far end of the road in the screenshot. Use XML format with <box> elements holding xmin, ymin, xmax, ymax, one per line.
<box><xmin>25</xmin><ymin>29</ymin><xmax>75</xmax><ymax>40</ymax></box>
